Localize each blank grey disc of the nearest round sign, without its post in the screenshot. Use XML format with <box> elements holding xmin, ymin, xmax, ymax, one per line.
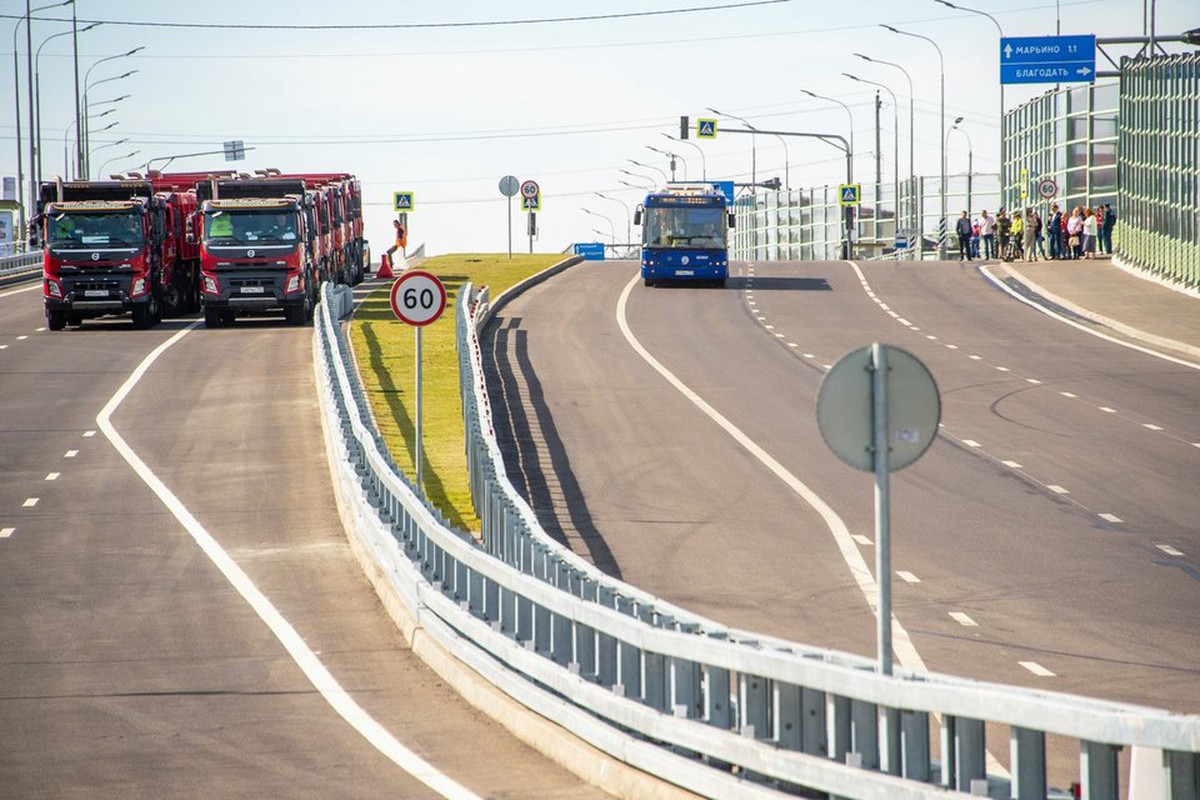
<box><xmin>817</xmin><ymin>344</ymin><xmax>942</xmax><ymax>473</ymax></box>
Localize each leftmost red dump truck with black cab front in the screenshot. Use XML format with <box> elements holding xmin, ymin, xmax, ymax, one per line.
<box><xmin>35</xmin><ymin>175</ymin><xmax>199</xmax><ymax>331</ymax></box>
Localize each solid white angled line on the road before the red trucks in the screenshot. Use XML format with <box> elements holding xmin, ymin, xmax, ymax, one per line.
<box><xmin>96</xmin><ymin>321</ymin><xmax>482</xmax><ymax>800</ymax></box>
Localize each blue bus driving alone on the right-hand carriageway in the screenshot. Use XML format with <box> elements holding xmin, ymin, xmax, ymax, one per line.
<box><xmin>634</xmin><ymin>184</ymin><xmax>733</xmax><ymax>287</ymax></box>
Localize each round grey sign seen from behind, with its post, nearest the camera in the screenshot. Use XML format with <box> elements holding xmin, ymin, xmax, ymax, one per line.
<box><xmin>817</xmin><ymin>342</ymin><xmax>942</xmax><ymax>675</ymax></box>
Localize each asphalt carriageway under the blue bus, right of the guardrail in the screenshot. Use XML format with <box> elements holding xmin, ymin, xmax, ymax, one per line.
<box><xmin>492</xmin><ymin>261</ymin><xmax>1200</xmax><ymax>786</ymax></box>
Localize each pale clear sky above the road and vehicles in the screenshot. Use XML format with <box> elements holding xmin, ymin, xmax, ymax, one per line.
<box><xmin>0</xmin><ymin>0</ymin><xmax>1200</xmax><ymax>260</ymax></box>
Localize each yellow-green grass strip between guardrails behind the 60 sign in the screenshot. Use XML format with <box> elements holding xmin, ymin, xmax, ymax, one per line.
<box><xmin>350</xmin><ymin>253</ymin><xmax>566</xmax><ymax>531</ymax></box>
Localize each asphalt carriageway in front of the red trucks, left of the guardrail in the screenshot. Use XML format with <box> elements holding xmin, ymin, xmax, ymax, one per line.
<box><xmin>0</xmin><ymin>283</ymin><xmax>609</xmax><ymax>799</ymax></box>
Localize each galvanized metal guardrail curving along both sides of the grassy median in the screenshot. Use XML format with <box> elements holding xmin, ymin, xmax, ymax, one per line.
<box><xmin>314</xmin><ymin>277</ymin><xmax>1200</xmax><ymax>800</ymax></box>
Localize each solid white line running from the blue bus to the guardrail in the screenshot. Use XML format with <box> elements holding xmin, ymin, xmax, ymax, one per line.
<box><xmin>617</xmin><ymin>275</ymin><xmax>928</xmax><ymax>672</ymax></box>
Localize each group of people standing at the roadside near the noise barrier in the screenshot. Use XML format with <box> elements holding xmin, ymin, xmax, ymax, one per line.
<box><xmin>954</xmin><ymin>203</ymin><xmax>1117</xmax><ymax>261</ymax></box>
